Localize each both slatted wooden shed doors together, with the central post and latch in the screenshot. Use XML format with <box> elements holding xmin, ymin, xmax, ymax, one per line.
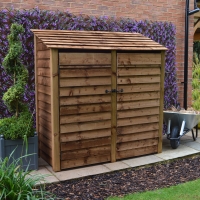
<box><xmin>59</xmin><ymin>51</ymin><xmax>163</xmax><ymax>169</ymax></box>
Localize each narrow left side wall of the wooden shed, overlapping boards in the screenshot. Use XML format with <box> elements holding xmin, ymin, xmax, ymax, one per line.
<box><xmin>36</xmin><ymin>38</ymin><xmax>52</xmax><ymax>165</ymax></box>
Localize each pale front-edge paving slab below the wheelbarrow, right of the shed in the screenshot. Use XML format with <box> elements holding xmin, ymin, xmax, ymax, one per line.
<box><xmin>156</xmin><ymin>144</ymin><xmax>199</xmax><ymax>160</ymax></box>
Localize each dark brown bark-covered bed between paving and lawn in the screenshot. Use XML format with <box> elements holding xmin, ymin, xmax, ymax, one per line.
<box><xmin>46</xmin><ymin>155</ymin><xmax>200</xmax><ymax>200</ymax></box>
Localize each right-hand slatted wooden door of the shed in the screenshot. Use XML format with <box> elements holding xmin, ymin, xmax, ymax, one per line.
<box><xmin>116</xmin><ymin>53</ymin><xmax>161</xmax><ymax>159</ymax></box>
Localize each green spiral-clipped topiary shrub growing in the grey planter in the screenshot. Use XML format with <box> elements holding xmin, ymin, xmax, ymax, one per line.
<box><xmin>0</xmin><ymin>24</ymin><xmax>34</xmax><ymax>140</ymax></box>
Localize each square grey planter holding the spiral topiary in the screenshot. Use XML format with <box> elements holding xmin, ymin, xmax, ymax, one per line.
<box><xmin>0</xmin><ymin>134</ymin><xmax>38</xmax><ymax>170</ymax></box>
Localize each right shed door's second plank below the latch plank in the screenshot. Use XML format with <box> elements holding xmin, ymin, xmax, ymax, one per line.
<box><xmin>117</xmin><ymin>99</ymin><xmax>160</xmax><ymax>110</ymax></box>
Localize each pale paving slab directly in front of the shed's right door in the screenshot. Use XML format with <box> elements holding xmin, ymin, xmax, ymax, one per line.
<box><xmin>122</xmin><ymin>155</ymin><xmax>163</xmax><ymax>167</ymax></box>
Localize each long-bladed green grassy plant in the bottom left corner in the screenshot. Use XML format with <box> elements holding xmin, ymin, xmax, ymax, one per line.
<box><xmin>0</xmin><ymin>153</ymin><xmax>54</xmax><ymax>200</ymax></box>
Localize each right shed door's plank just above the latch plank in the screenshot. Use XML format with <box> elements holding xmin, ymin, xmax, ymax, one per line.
<box><xmin>117</xmin><ymin>76</ymin><xmax>160</xmax><ymax>85</ymax></box>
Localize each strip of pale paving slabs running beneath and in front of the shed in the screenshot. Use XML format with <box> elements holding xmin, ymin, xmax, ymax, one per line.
<box><xmin>32</xmin><ymin>130</ymin><xmax>200</xmax><ymax>183</ymax></box>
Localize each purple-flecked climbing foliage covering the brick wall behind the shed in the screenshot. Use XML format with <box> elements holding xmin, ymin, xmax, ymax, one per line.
<box><xmin>0</xmin><ymin>8</ymin><xmax>178</xmax><ymax>124</ymax></box>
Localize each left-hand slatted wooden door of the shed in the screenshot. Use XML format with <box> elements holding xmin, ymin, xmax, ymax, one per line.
<box><xmin>59</xmin><ymin>52</ymin><xmax>111</xmax><ymax>169</ymax></box>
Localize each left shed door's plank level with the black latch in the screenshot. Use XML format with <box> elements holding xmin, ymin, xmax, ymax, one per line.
<box><xmin>60</xmin><ymin>86</ymin><xmax>111</xmax><ymax>96</ymax></box>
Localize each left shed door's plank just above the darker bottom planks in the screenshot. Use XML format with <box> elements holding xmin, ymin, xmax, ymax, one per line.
<box><xmin>60</xmin><ymin>128</ymin><xmax>111</xmax><ymax>142</ymax></box>
